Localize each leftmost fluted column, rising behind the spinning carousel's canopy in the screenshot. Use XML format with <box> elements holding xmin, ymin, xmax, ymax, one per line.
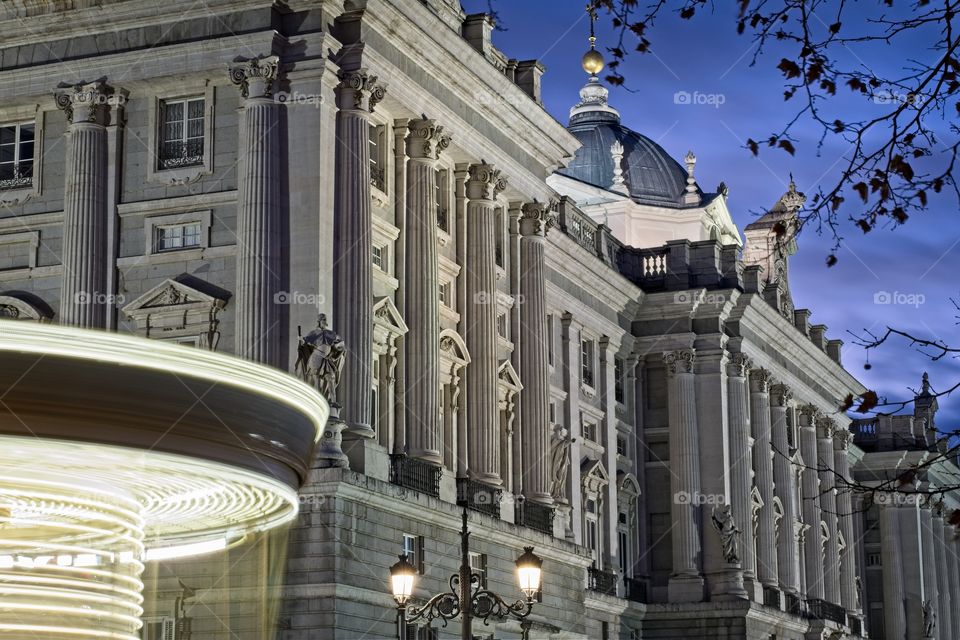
<box><xmin>56</xmin><ymin>81</ymin><xmax>113</xmax><ymax>328</ymax></box>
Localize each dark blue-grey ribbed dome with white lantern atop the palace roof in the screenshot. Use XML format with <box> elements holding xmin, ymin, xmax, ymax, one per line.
<box><xmin>558</xmin><ymin>77</ymin><xmax>687</xmax><ymax>207</ymax></box>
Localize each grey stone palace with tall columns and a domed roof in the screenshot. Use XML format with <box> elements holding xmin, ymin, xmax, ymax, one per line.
<box><xmin>0</xmin><ymin>0</ymin><xmax>960</xmax><ymax>640</ymax></box>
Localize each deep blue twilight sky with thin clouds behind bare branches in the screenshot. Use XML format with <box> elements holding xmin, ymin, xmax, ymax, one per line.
<box><xmin>463</xmin><ymin>0</ymin><xmax>960</xmax><ymax>430</ymax></box>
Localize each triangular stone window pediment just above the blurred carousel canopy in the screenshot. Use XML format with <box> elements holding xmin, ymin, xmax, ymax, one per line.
<box><xmin>122</xmin><ymin>273</ymin><xmax>230</xmax><ymax>350</ymax></box>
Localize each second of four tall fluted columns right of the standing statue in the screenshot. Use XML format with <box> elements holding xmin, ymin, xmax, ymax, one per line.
<box><xmin>403</xmin><ymin>120</ymin><xmax>450</xmax><ymax>465</ymax></box>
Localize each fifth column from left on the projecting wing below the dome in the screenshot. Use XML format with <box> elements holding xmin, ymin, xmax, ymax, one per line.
<box><xmin>800</xmin><ymin>405</ymin><xmax>823</xmax><ymax>600</ymax></box>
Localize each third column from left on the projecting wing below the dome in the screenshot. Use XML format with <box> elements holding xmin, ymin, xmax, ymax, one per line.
<box><xmin>750</xmin><ymin>369</ymin><xmax>779</xmax><ymax>589</ymax></box>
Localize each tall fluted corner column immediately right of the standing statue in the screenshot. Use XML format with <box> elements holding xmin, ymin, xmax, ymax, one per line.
<box><xmin>333</xmin><ymin>69</ymin><xmax>382</xmax><ymax>438</ymax></box>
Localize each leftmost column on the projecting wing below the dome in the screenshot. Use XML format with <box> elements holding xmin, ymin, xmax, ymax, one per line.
<box><xmin>663</xmin><ymin>349</ymin><xmax>703</xmax><ymax>602</ymax></box>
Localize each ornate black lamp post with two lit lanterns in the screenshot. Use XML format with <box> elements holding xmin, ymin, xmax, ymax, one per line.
<box><xmin>390</xmin><ymin>482</ymin><xmax>543</xmax><ymax>640</ymax></box>
